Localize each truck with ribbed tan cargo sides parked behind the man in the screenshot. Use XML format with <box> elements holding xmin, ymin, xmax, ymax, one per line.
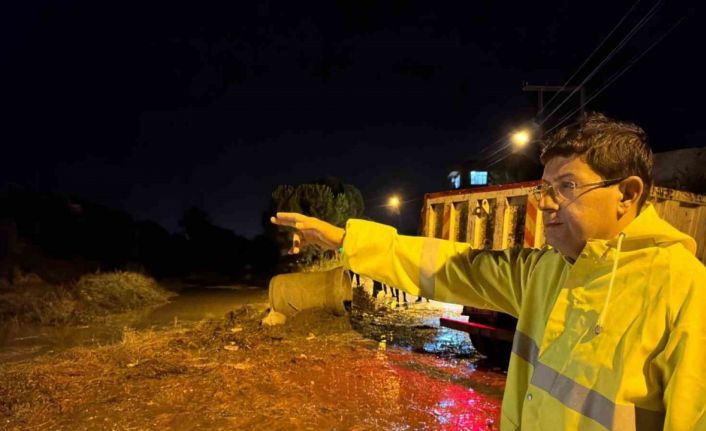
<box><xmin>421</xmin><ymin>181</ymin><xmax>706</xmax><ymax>368</ymax></box>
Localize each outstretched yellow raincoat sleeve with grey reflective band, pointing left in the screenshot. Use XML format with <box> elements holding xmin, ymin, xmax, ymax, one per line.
<box><xmin>343</xmin><ymin>219</ymin><xmax>542</xmax><ymax>316</ymax></box>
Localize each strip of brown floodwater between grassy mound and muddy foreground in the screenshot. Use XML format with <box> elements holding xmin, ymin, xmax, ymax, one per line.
<box><xmin>0</xmin><ymin>286</ymin><xmax>267</xmax><ymax>363</ymax></box>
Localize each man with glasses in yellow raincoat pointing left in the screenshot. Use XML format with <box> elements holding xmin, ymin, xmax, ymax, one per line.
<box><xmin>272</xmin><ymin>114</ymin><xmax>706</xmax><ymax>431</ymax></box>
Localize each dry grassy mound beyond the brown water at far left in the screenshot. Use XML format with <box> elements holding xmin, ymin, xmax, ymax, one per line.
<box><xmin>0</xmin><ymin>272</ymin><xmax>172</xmax><ymax>325</ymax></box>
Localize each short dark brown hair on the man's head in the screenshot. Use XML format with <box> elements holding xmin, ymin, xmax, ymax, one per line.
<box><xmin>540</xmin><ymin>113</ymin><xmax>653</xmax><ymax>210</ymax></box>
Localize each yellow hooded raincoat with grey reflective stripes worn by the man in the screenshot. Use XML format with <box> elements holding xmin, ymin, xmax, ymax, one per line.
<box><xmin>343</xmin><ymin>206</ymin><xmax>706</xmax><ymax>431</ymax></box>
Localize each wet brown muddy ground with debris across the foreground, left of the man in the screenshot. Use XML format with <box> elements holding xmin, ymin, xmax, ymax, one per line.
<box><xmin>0</xmin><ymin>288</ymin><xmax>504</xmax><ymax>430</ymax></box>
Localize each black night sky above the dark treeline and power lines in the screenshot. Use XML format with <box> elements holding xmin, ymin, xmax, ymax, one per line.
<box><xmin>0</xmin><ymin>0</ymin><xmax>706</xmax><ymax>237</ymax></box>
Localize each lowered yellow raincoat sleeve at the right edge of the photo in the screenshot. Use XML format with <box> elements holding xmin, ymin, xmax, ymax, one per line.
<box><xmin>656</xmin><ymin>263</ymin><xmax>706</xmax><ymax>431</ymax></box>
